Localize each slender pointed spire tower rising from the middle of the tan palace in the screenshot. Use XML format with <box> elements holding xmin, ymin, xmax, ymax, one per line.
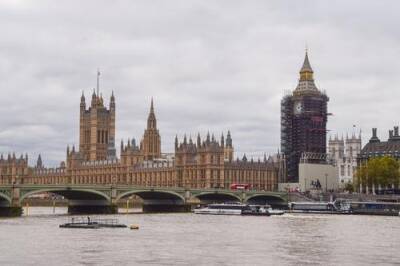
<box><xmin>140</xmin><ymin>99</ymin><xmax>161</xmax><ymax>160</ymax></box>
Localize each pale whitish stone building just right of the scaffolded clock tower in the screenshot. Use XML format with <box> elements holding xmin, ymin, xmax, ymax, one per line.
<box><xmin>328</xmin><ymin>132</ymin><xmax>362</xmax><ymax>187</ymax></box>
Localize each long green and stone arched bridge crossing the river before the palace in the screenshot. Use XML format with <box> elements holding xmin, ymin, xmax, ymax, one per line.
<box><xmin>0</xmin><ymin>184</ymin><xmax>287</xmax><ymax>216</ymax></box>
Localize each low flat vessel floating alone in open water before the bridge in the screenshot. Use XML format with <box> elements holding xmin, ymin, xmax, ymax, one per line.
<box><xmin>59</xmin><ymin>217</ymin><xmax>127</xmax><ymax>229</ymax></box>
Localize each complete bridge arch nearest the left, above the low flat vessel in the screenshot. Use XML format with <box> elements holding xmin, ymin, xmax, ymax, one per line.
<box><xmin>19</xmin><ymin>187</ymin><xmax>111</xmax><ymax>202</ymax></box>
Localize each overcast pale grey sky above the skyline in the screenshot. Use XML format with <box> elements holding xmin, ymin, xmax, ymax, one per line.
<box><xmin>0</xmin><ymin>0</ymin><xmax>400</xmax><ymax>165</ymax></box>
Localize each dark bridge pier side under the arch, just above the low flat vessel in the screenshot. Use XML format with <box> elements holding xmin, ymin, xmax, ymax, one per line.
<box><xmin>68</xmin><ymin>200</ymin><xmax>118</xmax><ymax>214</ymax></box>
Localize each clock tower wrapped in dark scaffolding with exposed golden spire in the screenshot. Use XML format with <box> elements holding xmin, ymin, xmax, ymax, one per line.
<box><xmin>281</xmin><ymin>52</ymin><xmax>329</xmax><ymax>182</ymax></box>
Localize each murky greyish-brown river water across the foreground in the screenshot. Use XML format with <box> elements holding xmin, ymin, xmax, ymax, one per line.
<box><xmin>0</xmin><ymin>207</ymin><xmax>400</xmax><ymax>266</ymax></box>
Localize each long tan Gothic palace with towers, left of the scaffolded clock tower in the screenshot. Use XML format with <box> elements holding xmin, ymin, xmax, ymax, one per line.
<box><xmin>0</xmin><ymin>82</ymin><xmax>281</xmax><ymax>191</ymax></box>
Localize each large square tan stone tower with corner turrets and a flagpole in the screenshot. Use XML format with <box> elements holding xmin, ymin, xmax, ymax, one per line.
<box><xmin>79</xmin><ymin>73</ymin><xmax>115</xmax><ymax>161</ymax></box>
